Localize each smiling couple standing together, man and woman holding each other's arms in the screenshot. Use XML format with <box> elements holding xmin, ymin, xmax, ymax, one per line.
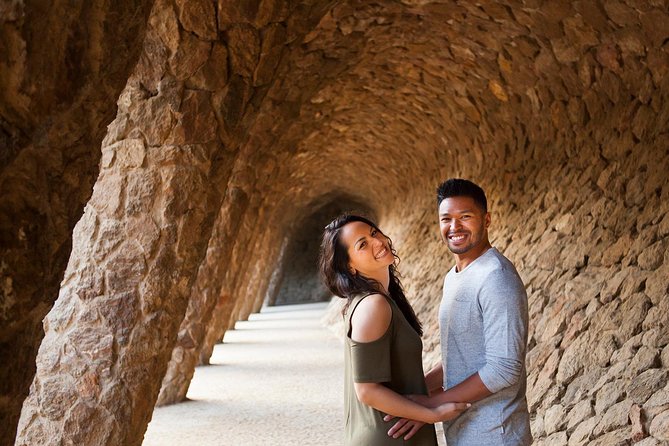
<box><xmin>319</xmin><ymin>179</ymin><xmax>532</xmax><ymax>446</ymax></box>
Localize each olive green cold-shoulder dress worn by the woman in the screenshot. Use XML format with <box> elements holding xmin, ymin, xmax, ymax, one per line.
<box><xmin>344</xmin><ymin>296</ymin><xmax>437</xmax><ymax>446</ymax></box>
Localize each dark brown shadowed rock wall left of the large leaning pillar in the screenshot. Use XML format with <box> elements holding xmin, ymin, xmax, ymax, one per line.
<box><xmin>0</xmin><ymin>0</ymin><xmax>151</xmax><ymax>445</ymax></box>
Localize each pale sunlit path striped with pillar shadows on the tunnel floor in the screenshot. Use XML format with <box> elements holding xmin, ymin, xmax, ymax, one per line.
<box><xmin>143</xmin><ymin>304</ymin><xmax>344</xmax><ymax>446</ymax></box>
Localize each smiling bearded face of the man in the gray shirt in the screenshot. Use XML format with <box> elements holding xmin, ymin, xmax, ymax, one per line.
<box><xmin>439</xmin><ymin>197</ymin><xmax>490</xmax><ymax>254</ymax></box>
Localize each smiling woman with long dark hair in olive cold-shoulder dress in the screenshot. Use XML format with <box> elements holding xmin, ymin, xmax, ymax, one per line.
<box><xmin>319</xmin><ymin>214</ymin><xmax>468</xmax><ymax>446</ymax></box>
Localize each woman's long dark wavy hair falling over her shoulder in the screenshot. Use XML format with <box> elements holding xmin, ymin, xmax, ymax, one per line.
<box><xmin>318</xmin><ymin>214</ymin><xmax>423</xmax><ymax>336</ymax></box>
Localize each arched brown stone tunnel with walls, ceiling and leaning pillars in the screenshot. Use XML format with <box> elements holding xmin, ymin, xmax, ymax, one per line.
<box><xmin>0</xmin><ymin>0</ymin><xmax>669</xmax><ymax>446</ymax></box>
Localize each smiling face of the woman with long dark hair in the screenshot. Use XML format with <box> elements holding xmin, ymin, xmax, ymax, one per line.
<box><xmin>341</xmin><ymin>221</ymin><xmax>395</xmax><ymax>277</ymax></box>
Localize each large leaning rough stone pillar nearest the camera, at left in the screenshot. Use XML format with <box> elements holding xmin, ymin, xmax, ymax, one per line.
<box><xmin>17</xmin><ymin>2</ymin><xmax>228</xmax><ymax>438</ymax></box>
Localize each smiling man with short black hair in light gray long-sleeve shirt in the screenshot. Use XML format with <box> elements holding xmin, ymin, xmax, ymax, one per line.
<box><xmin>388</xmin><ymin>178</ymin><xmax>532</xmax><ymax>446</ymax></box>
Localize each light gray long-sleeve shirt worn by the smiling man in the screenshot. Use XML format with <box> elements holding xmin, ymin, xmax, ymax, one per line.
<box><xmin>439</xmin><ymin>248</ymin><xmax>532</xmax><ymax>446</ymax></box>
